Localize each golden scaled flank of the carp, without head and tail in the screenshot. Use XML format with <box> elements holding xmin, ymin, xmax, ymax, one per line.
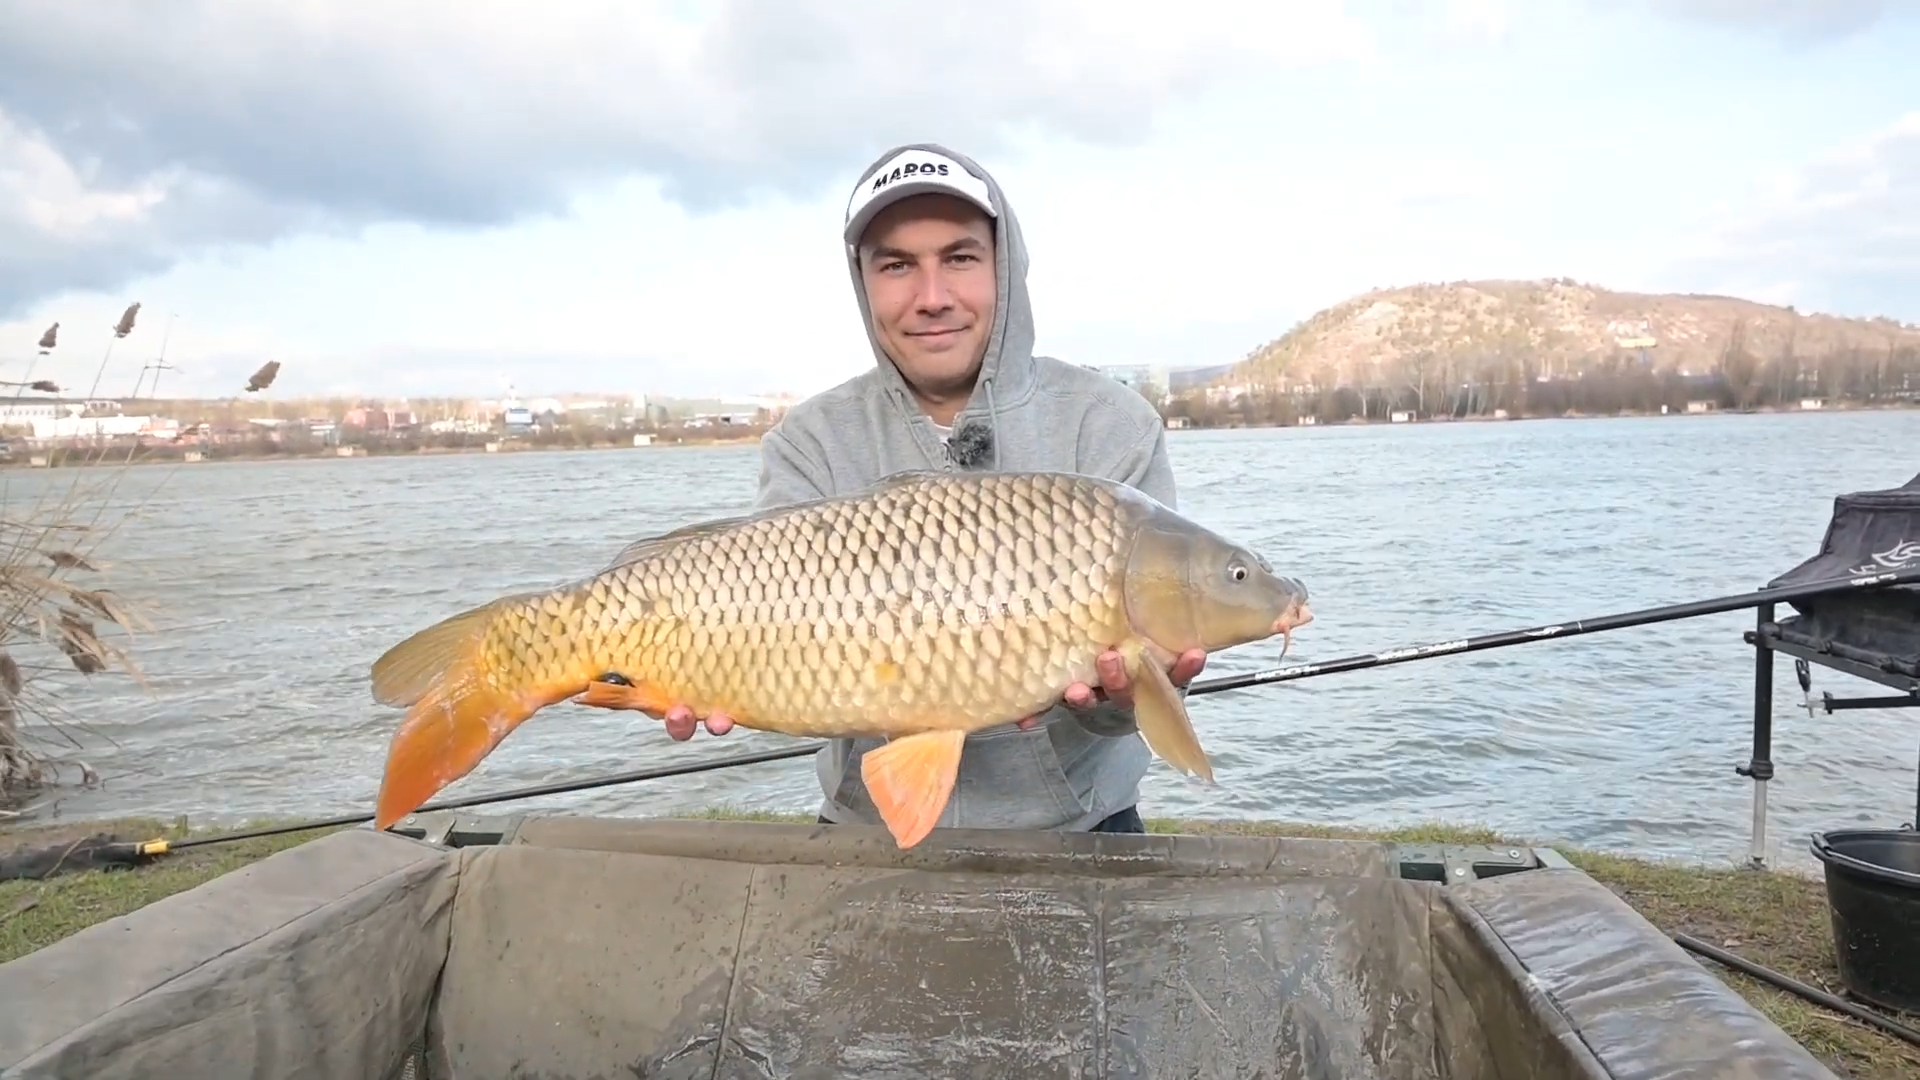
<box><xmin>541</xmin><ymin>477</ymin><xmax>1125</xmax><ymax>736</ymax></box>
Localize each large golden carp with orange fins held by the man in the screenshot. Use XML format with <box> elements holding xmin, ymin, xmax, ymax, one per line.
<box><xmin>372</xmin><ymin>473</ymin><xmax>1313</xmax><ymax>847</ymax></box>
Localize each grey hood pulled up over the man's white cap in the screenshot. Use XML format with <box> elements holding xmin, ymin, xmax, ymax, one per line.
<box><xmin>843</xmin><ymin>142</ymin><xmax>1033</xmax><ymax>471</ymax></box>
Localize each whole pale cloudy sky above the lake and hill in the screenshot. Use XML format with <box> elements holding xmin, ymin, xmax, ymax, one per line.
<box><xmin>0</xmin><ymin>0</ymin><xmax>1920</xmax><ymax>396</ymax></box>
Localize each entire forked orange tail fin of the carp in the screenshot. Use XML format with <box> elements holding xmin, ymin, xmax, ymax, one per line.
<box><xmin>372</xmin><ymin>596</ymin><xmax>586</xmax><ymax>830</ymax></box>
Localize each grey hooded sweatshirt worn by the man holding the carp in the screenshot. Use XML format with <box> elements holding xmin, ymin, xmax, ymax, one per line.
<box><xmin>758</xmin><ymin>142</ymin><xmax>1177</xmax><ymax>830</ymax></box>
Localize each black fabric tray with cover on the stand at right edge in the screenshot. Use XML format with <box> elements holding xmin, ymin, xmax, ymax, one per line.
<box><xmin>1766</xmin><ymin>475</ymin><xmax>1920</xmax><ymax>676</ymax></box>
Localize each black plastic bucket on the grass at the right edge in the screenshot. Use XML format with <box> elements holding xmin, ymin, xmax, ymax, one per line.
<box><xmin>1812</xmin><ymin>828</ymin><xmax>1920</xmax><ymax>1013</ymax></box>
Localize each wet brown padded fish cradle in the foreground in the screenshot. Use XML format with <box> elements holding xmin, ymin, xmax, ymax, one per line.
<box><xmin>0</xmin><ymin>819</ymin><xmax>1834</xmax><ymax>1080</ymax></box>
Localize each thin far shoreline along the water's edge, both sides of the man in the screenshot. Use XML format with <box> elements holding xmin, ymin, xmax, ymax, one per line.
<box><xmin>0</xmin><ymin>402</ymin><xmax>1920</xmax><ymax>463</ymax></box>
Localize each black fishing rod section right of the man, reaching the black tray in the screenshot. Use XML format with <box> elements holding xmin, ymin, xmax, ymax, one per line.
<box><xmin>1187</xmin><ymin>567</ymin><xmax>1920</xmax><ymax>696</ymax></box>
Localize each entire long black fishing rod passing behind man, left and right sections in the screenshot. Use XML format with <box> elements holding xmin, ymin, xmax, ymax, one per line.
<box><xmin>0</xmin><ymin>567</ymin><xmax>1920</xmax><ymax>880</ymax></box>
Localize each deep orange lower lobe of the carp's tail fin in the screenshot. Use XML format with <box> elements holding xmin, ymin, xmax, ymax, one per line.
<box><xmin>372</xmin><ymin>673</ymin><xmax>568</xmax><ymax>828</ymax></box>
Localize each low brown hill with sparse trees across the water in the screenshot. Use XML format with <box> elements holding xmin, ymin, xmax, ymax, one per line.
<box><xmin>1223</xmin><ymin>279</ymin><xmax>1920</xmax><ymax>404</ymax></box>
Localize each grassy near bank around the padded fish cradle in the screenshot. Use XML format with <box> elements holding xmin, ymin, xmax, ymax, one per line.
<box><xmin>0</xmin><ymin>811</ymin><xmax>1920</xmax><ymax>1080</ymax></box>
